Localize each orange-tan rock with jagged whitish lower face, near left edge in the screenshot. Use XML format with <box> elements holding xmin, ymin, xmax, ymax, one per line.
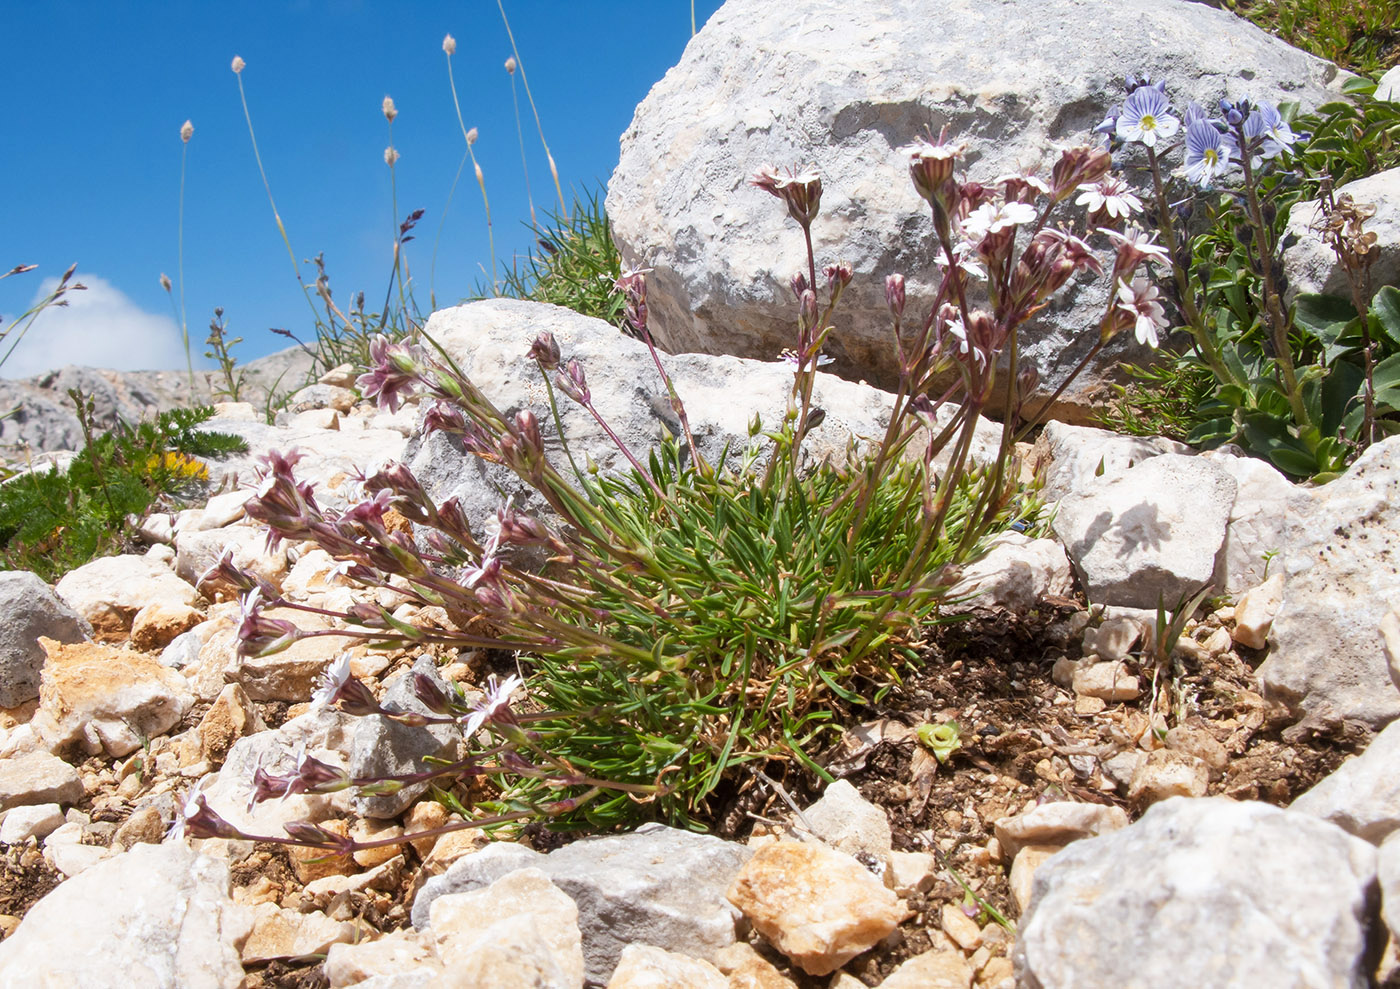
<box><xmin>31</xmin><ymin>639</ymin><xmax>195</xmax><ymax>756</ymax></box>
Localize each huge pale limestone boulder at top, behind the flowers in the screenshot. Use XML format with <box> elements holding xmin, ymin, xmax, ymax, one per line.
<box><xmin>606</xmin><ymin>0</ymin><xmax>1338</xmax><ymax>417</ymax></box>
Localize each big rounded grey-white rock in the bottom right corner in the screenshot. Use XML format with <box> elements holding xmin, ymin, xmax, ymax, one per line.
<box><xmin>1012</xmin><ymin>797</ymin><xmax>1385</xmax><ymax>989</ymax></box>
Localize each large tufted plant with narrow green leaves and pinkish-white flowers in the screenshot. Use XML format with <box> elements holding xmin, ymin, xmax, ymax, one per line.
<box><xmin>204</xmin><ymin>130</ymin><xmax>1161</xmax><ymax>827</ymax></box>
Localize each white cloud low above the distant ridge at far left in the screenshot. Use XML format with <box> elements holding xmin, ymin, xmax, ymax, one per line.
<box><xmin>0</xmin><ymin>272</ymin><xmax>200</xmax><ymax>378</ymax></box>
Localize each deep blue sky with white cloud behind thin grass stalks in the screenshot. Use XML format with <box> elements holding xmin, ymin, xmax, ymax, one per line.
<box><xmin>8</xmin><ymin>0</ymin><xmax>720</xmax><ymax>377</ymax></box>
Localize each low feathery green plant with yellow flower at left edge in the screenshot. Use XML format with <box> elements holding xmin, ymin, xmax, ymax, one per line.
<box><xmin>0</xmin><ymin>392</ymin><xmax>246</xmax><ymax>581</ymax></box>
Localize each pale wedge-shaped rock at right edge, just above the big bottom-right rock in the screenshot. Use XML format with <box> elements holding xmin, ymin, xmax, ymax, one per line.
<box><xmin>1289</xmin><ymin>721</ymin><xmax>1400</xmax><ymax>845</ymax></box>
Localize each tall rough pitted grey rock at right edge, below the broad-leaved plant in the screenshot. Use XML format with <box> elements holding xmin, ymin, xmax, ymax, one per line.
<box><xmin>1259</xmin><ymin>437</ymin><xmax>1400</xmax><ymax>727</ymax></box>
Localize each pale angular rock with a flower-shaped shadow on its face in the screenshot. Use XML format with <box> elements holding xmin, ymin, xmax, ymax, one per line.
<box><xmin>1054</xmin><ymin>454</ymin><xmax>1236</xmax><ymax>608</ymax></box>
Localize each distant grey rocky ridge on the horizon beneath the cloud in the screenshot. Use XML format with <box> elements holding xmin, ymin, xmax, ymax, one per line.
<box><xmin>0</xmin><ymin>347</ymin><xmax>312</xmax><ymax>462</ymax></box>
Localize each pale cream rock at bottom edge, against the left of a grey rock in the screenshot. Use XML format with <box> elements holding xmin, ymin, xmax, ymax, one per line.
<box><xmin>428</xmin><ymin>869</ymin><xmax>584</xmax><ymax>989</ymax></box>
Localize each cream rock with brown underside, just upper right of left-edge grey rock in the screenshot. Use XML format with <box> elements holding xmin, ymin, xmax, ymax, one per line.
<box><xmin>53</xmin><ymin>556</ymin><xmax>199</xmax><ymax>640</ymax></box>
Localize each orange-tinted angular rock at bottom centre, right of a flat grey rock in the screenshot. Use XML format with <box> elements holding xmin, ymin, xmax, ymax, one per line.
<box><xmin>728</xmin><ymin>841</ymin><xmax>904</xmax><ymax>975</ymax></box>
